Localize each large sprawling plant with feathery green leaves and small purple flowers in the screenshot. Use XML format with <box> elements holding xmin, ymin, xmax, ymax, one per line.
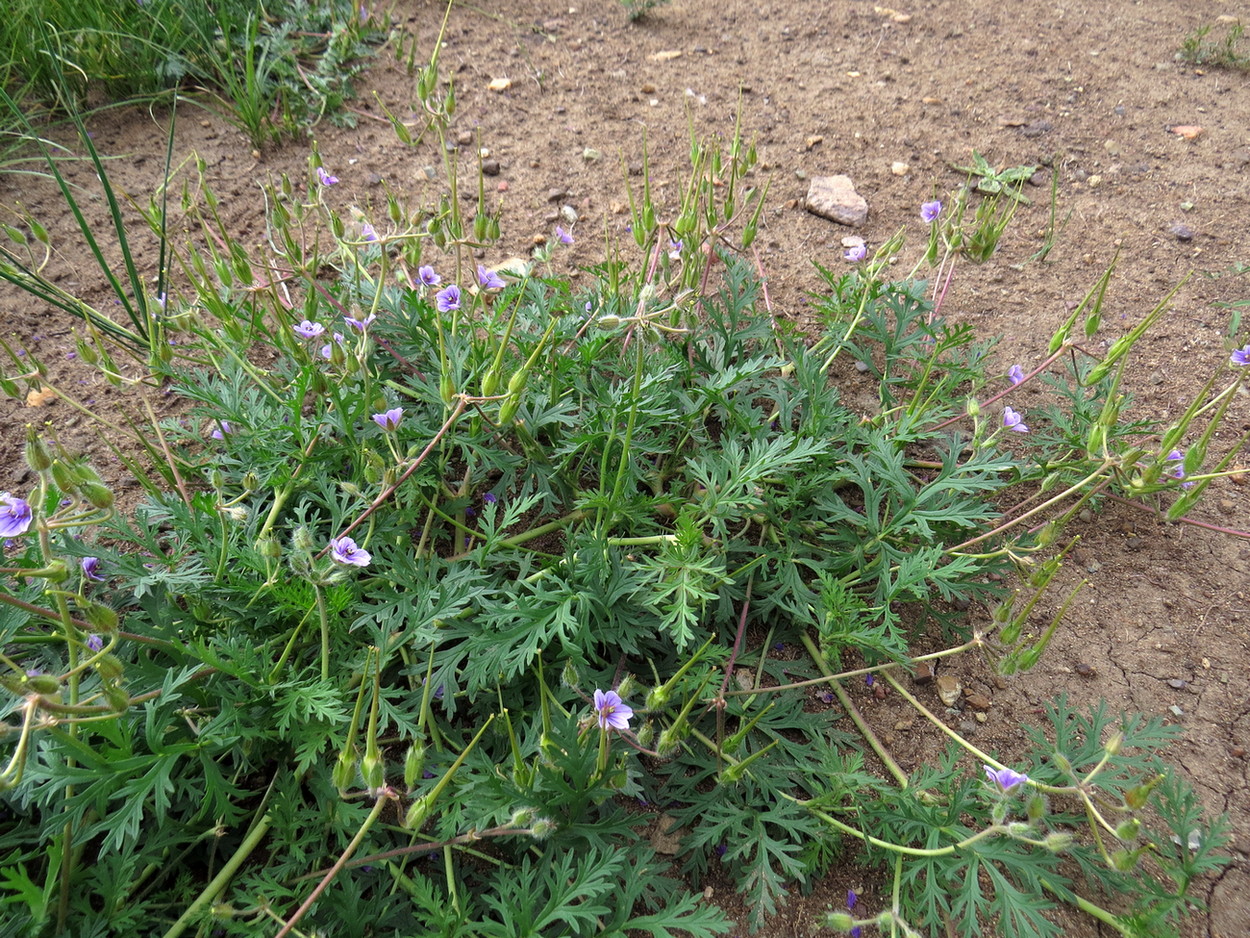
<box><xmin>0</xmin><ymin>45</ymin><xmax>1243</xmax><ymax>938</ymax></box>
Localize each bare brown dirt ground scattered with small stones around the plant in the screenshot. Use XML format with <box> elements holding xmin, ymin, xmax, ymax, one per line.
<box><xmin>0</xmin><ymin>0</ymin><xmax>1250</xmax><ymax>938</ymax></box>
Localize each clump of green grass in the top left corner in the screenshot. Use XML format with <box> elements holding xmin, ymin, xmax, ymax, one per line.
<box><xmin>0</xmin><ymin>0</ymin><xmax>385</xmax><ymax>146</ymax></box>
